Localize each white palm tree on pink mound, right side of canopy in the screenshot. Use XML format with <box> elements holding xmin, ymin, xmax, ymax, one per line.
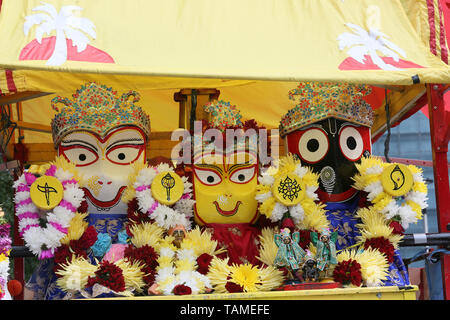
<box><xmin>337</xmin><ymin>23</ymin><xmax>422</xmax><ymax>70</ymax></box>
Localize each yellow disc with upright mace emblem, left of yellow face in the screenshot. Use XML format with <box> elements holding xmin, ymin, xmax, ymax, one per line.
<box><xmin>151</xmin><ymin>171</ymin><xmax>184</xmax><ymax>205</ymax></box>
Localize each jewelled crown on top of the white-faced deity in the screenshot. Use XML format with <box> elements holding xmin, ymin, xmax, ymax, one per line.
<box><xmin>51</xmin><ymin>82</ymin><xmax>150</xmax><ymax>146</ymax></box>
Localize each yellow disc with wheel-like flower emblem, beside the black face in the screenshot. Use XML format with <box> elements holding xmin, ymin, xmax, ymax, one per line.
<box><xmin>272</xmin><ymin>174</ymin><xmax>305</xmax><ymax>206</ymax></box>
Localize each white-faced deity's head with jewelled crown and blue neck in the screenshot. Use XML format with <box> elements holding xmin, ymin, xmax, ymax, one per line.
<box><xmin>52</xmin><ymin>83</ymin><xmax>150</xmax><ymax>239</ymax></box>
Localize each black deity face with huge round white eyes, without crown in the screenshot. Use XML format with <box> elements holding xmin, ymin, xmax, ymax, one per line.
<box><xmin>286</xmin><ymin>118</ymin><xmax>372</xmax><ymax>201</ymax></box>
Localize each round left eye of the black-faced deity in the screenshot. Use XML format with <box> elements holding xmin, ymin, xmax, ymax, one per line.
<box><xmin>298</xmin><ymin>128</ymin><xmax>329</xmax><ymax>163</ymax></box>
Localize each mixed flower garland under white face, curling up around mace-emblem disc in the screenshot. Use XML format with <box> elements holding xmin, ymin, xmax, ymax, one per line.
<box><xmin>55</xmin><ymin>163</ymin><xmax>193</xmax><ymax>297</ymax></box>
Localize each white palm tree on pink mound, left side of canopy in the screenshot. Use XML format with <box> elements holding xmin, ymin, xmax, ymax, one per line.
<box><xmin>20</xmin><ymin>2</ymin><xmax>113</xmax><ymax>66</ymax></box>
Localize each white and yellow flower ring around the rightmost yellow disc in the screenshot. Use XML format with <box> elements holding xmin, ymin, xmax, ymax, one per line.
<box><xmin>353</xmin><ymin>156</ymin><xmax>428</xmax><ymax>229</ymax></box>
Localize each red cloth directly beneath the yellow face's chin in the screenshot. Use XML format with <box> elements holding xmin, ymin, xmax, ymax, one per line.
<box><xmin>205</xmin><ymin>223</ymin><xmax>262</xmax><ymax>266</ymax></box>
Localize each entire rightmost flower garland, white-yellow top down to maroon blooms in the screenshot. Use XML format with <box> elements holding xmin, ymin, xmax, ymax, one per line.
<box><xmin>333</xmin><ymin>156</ymin><xmax>427</xmax><ymax>286</ymax></box>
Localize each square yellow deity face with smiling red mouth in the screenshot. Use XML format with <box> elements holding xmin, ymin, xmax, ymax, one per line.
<box><xmin>194</xmin><ymin>152</ymin><xmax>258</xmax><ymax>225</ymax></box>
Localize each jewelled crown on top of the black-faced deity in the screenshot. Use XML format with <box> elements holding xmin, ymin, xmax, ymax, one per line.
<box><xmin>280</xmin><ymin>82</ymin><xmax>373</xmax><ymax>137</ymax></box>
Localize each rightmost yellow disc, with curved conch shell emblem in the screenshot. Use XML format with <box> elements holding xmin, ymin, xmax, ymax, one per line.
<box><xmin>381</xmin><ymin>163</ymin><xmax>414</xmax><ymax>197</ymax></box>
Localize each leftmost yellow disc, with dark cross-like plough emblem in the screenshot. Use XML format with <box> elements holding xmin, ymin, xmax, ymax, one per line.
<box><xmin>30</xmin><ymin>176</ymin><xmax>64</xmax><ymax>210</ymax></box>
